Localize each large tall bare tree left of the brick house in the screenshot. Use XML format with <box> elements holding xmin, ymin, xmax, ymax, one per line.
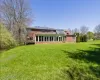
<box><xmin>0</xmin><ymin>0</ymin><xmax>33</xmax><ymax>43</ymax></box>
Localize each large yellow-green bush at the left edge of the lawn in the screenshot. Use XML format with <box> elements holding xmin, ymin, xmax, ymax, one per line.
<box><xmin>0</xmin><ymin>24</ymin><xmax>16</xmax><ymax>49</ymax></box>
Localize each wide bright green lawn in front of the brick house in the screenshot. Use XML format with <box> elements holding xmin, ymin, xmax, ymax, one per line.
<box><xmin>0</xmin><ymin>41</ymin><xmax>100</xmax><ymax>80</ymax></box>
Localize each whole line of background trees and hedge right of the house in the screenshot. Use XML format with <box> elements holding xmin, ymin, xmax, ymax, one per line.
<box><xmin>68</xmin><ymin>24</ymin><xmax>100</xmax><ymax>42</ymax></box>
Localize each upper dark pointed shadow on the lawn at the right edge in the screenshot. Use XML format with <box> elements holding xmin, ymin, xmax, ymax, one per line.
<box><xmin>62</xmin><ymin>44</ymin><xmax>100</xmax><ymax>64</ymax></box>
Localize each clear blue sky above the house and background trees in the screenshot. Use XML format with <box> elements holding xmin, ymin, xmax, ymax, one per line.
<box><xmin>30</xmin><ymin>0</ymin><xmax>100</xmax><ymax>31</ymax></box>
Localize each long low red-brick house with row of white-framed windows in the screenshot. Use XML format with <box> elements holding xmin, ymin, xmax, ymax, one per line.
<box><xmin>26</xmin><ymin>27</ymin><xmax>76</xmax><ymax>44</ymax></box>
